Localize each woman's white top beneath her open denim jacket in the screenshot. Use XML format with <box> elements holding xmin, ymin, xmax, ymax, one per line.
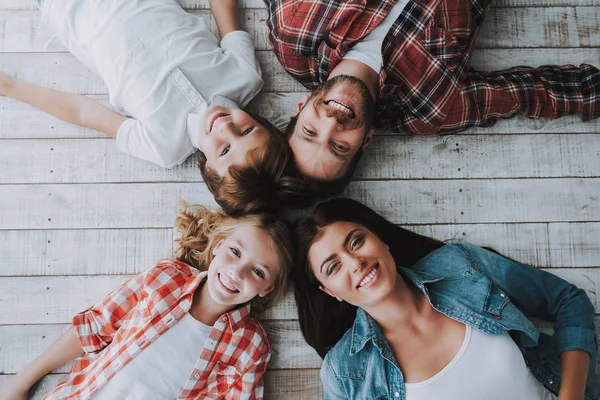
<box><xmin>405</xmin><ymin>325</ymin><xmax>556</xmax><ymax>400</ymax></box>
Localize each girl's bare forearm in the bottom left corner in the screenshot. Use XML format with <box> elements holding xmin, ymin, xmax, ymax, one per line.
<box><xmin>0</xmin><ymin>329</ymin><xmax>83</xmax><ymax>400</ymax></box>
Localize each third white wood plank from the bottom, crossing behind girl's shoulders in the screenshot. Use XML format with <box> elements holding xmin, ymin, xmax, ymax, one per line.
<box><xmin>0</xmin><ymin>268</ymin><xmax>600</xmax><ymax>325</ymax></box>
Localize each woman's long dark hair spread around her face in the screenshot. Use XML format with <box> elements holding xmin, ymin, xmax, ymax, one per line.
<box><xmin>293</xmin><ymin>199</ymin><xmax>443</xmax><ymax>357</ymax></box>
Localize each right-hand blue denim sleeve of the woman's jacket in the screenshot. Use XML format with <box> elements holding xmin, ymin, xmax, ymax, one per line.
<box><xmin>457</xmin><ymin>244</ymin><xmax>597</xmax><ymax>358</ymax></box>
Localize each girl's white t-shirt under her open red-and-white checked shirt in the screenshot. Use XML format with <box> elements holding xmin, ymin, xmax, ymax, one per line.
<box><xmin>93</xmin><ymin>313</ymin><xmax>212</xmax><ymax>400</ymax></box>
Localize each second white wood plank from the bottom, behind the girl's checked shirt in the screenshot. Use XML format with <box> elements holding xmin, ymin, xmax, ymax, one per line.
<box><xmin>0</xmin><ymin>320</ymin><xmax>321</xmax><ymax>373</ymax></box>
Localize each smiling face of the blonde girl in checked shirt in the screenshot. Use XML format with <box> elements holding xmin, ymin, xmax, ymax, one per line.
<box><xmin>206</xmin><ymin>225</ymin><xmax>281</xmax><ymax>306</ymax></box>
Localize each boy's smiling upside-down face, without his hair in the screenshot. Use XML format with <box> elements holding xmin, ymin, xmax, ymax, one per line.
<box><xmin>199</xmin><ymin>106</ymin><xmax>269</xmax><ymax>177</ymax></box>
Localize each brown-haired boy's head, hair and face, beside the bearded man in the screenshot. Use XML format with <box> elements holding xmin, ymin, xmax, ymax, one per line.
<box><xmin>198</xmin><ymin>106</ymin><xmax>312</xmax><ymax>216</ymax></box>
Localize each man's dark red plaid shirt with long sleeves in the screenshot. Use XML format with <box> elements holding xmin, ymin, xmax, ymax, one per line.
<box><xmin>265</xmin><ymin>0</ymin><xmax>600</xmax><ymax>134</ymax></box>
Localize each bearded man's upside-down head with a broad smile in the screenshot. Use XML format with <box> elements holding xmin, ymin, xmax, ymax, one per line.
<box><xmin>286</xmin><ymin>75</ymin><xmax>375</xmax><ymax>194</ymax></box>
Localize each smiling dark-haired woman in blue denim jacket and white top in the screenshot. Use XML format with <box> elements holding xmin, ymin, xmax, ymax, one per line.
<box><xmin>294</xmin><ymin>199</ymin><xmax>600</xmax><ymax>400</ymax></box>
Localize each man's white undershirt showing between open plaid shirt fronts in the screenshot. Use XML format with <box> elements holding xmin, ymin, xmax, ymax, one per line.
<box><xmin>344</xmin><ymin>0</ymin><xmax>408</xmax><ymax>73</ymax></box>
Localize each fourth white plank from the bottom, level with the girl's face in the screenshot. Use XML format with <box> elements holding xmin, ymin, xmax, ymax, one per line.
<box><xmin>0</xmin><ymin>222</ymin><xmax>600</xmax><ymax>276</ymax></box>
